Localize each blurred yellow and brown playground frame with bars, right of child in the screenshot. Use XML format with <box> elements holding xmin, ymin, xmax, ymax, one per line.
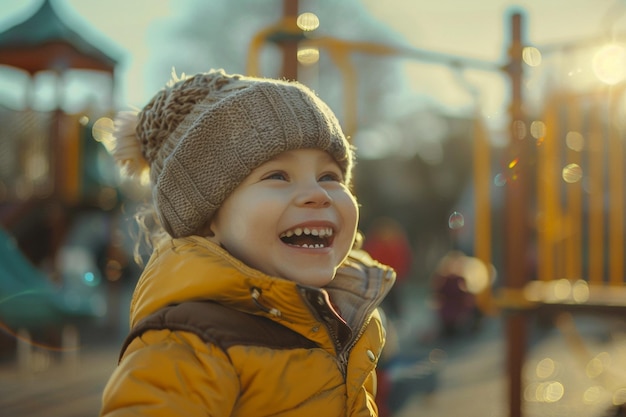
<box><xmin>249</xmin><ymin>1</ymin><xmax>626</xmax><ymax>417</ymax></box>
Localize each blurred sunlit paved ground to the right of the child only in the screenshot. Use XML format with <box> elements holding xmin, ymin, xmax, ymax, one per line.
<box><xmin>394</xmin><ymin>282</ymin><xmax>626</xmax><ymax>417</ymax></box>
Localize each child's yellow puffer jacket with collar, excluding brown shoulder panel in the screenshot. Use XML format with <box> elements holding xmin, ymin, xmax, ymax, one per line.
<box><xmin>100</xmin><ymin>237</ymin><xmax>395</xmax><ymax>417</ymax></box>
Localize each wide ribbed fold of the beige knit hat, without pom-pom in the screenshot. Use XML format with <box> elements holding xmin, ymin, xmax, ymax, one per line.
<box><xmin>153</xmin><ymin>76</ymin><xmax>352</xmax><ymax>237</ymax></box>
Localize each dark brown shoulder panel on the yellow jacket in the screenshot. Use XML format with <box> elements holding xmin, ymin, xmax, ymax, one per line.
<box><xmin>120</xmin><ymin>301</ymin><xmax>317</xmax><ymax>358</ymax></box>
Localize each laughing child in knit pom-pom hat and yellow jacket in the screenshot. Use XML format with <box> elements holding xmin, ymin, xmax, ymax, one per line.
<box><xmin>101</xmin><ymin>71</ymin><xmax>395</xmax><ymax>417</ymax></box>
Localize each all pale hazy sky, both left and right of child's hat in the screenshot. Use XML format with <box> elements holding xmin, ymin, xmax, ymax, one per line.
<box><xmin>0</xmin><ymin>0</ymin><xmax>626</xmax><ymax>126</ymax></box>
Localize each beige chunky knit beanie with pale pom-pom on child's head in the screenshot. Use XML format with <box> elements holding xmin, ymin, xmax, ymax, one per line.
<box><xmin>113</xmin><ymin>70</ymin><xmax>354</xmax><ymax>237</ymax></box>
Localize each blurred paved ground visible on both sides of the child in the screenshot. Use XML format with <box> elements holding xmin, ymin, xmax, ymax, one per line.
<box><xmin>0</xmin><ymin>282</ymin><xmax>626</xmax><ymax>417</ymax></box>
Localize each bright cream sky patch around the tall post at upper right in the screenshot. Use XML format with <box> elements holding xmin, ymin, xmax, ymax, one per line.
<box><xmin>363</xmin><ymin>0</ymin><xmax>626</xmax><ymax>128</ymax></box>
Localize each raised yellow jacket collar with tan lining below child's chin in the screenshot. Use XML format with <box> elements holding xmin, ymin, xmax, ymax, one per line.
<box><xmin>130</xmin><ymin>236</ymin><xmax>395</xmax><ymax>342</ymax></box>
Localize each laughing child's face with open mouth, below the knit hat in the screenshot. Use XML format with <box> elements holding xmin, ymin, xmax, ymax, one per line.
<box><xmin>211</xmin><ymin>149</ymin><xmax>359</xmax><ymax>287</ymax></box>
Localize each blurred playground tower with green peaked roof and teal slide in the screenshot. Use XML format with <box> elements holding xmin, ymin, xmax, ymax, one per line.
<box><xmin>0</xmin><ymin>0</ymin><xmax>125</xmax><ymax>360</ymax></box>
